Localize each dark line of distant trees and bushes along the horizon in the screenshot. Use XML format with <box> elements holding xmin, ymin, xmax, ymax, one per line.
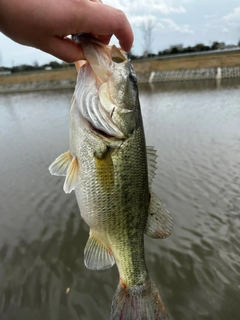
<box><xmin>0</xmin><ymin>40</ymin><xmax>240</xmax><ymax>75</ymax></box>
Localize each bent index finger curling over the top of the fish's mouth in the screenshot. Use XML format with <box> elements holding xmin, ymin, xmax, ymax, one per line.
<box><xmin>85</xmin><ymin>2</ymin><xmax>133</xmax><ymax>51</ymax></box>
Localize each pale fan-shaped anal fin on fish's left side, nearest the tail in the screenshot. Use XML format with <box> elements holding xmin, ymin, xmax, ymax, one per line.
<box><xmin>84</xmin><ymin>232</ymin><xmax>115</xmax><ymax>270</ymax></box>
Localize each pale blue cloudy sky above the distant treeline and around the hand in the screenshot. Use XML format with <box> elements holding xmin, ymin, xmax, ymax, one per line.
<box><xmin>0</xmin><ymin>0</ymin><xmax>240</xmax><ymax>67</ymax></box>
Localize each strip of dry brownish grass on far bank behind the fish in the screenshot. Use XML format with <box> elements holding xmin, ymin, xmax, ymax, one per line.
<box><xmin>0</xmin><ymin>52</ymin><xmax>240</xmax><ymax>85</ymax></box>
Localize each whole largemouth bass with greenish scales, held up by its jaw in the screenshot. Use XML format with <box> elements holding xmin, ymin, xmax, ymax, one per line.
<box><xmin>49</xmin><ymin>34</ymin><xmax>173</xmax><ymax>320</ymax></box>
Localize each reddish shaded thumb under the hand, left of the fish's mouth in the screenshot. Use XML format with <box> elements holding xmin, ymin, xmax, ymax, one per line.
<box><xmin>40</xmin><ymin>37</ymin><xmax>86</xmax><ymax>63</ymax></box>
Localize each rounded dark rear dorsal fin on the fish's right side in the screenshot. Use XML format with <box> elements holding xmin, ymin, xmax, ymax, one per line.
<box><xmin>145</xmin><ymin>192</ymin><xmax>173</xmax><ymax>239</ymax></box>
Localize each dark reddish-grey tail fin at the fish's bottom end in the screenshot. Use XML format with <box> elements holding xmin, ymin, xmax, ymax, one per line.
<box><xmin>110</xmin><ymin>279</ymin><xmax>168</xmax><ymax>320</ymax></box>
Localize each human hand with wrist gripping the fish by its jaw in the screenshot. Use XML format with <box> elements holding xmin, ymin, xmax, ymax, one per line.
<box><xmin>0</xmin><ymin>0</ymin><xmax>133</xmax><ymax>62</ymax></box>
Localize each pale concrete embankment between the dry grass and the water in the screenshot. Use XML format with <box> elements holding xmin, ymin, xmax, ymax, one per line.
<box><xmin>0</xmin><ymin>67</ymin><xmax>240</xmax><ymax>93</ymax></box>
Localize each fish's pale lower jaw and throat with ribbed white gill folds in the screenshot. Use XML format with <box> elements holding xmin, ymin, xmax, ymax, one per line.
<box><xmin>73</xmin><ymin>34</ymin><xmax>130</xmax><ymax>139</ymax></box>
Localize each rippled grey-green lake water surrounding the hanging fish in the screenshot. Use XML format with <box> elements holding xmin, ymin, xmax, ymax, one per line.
<box><xmin>0</xmin><ymin>80</ymin><xmax>240</xmax><ymax>320</ymax></box>
